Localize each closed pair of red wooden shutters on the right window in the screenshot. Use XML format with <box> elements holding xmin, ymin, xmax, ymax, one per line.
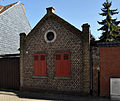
<box><xmin>55</xmin><ymin>52</ymin><xmax>70</xmax><ymax>77</ymax></box>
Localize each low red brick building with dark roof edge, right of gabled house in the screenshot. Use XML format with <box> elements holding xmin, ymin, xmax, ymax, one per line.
<box><xmin>91</xmin><ymin>41</ymin><xmax>120</xmax><ymax>96</ymax></box>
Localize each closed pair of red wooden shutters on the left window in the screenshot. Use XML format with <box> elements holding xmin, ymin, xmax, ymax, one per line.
<box><xmin>34</xmin><ymin>54</ymin><xmax>47</xmax><ymax>76</ymax></box>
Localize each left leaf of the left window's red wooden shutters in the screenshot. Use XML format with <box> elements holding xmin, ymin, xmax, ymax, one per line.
<box><xmin>33</xmin><ymin>54</ymin><xmax>39</xmax><ymax>75</ymax></box>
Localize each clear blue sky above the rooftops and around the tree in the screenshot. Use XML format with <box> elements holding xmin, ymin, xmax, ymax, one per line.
<box><xmin>0</xmin><ymin>0</ymin><xmax>120</xmax><ymax>38</ymax></box>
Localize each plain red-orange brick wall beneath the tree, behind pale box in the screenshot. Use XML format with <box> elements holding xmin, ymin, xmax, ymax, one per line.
<box><xmin>100</xmin><ymin>46</ymin><xmax>120</xmax><ymax>96</ymax></box>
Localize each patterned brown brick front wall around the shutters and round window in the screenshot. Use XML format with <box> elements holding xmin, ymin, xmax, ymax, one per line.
<box><xmin>20</xmin><ymin>10</ymin><xmax>90</xmax><ymax>94</ymax></box>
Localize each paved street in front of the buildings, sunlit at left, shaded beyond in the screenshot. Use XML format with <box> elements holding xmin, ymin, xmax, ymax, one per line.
<box><xmin>0</xmin><ymin>91</ymin><xmax>111</xmax><ymax>101</ymax></box>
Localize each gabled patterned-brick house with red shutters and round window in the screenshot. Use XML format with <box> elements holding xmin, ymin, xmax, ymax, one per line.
<box><xmin>20</xmin><ymin>7</ymin><xmax>90</xmax><ymax>94</ymax></box>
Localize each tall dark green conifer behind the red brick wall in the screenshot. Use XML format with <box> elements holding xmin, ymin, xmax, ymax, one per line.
<box><xmin>98</xmin><ymin>0</ymin><xmax>120</xmax><ymax>41</ymax></box>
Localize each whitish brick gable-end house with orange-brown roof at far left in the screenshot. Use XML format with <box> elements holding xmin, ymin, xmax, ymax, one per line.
<box><xmin>0</xmin><ymin>2</ymin><xmax>31</xmax><ymax>55</ymax></box>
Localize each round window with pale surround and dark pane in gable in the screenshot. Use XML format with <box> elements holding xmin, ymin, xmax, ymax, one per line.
<box><xmin>44</xmin><ymin>30</ymin><xmax>56</xmax><ymax>42</ymax></box>
